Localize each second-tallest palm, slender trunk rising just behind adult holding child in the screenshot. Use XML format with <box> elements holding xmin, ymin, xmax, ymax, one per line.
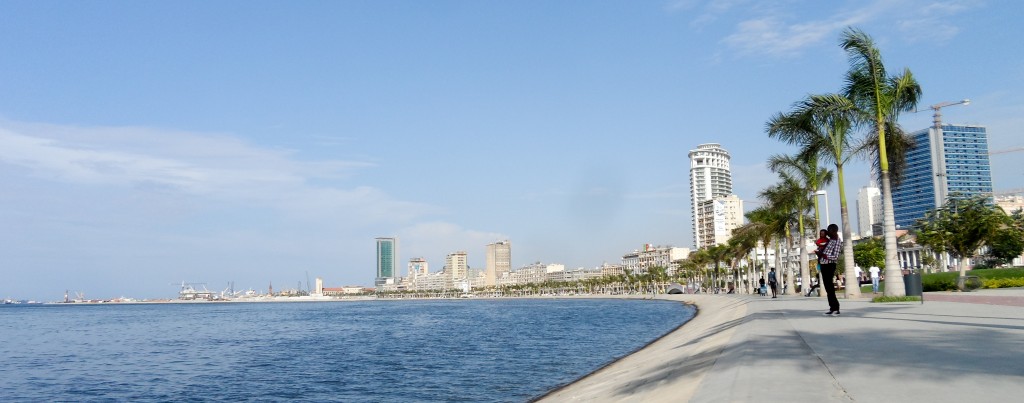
<box><xmin>768</xmin><ymin>94</ymin><xmax>864</xmax><ymax>298</ymax></box>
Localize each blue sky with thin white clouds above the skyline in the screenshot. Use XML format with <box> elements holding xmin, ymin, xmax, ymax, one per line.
<box><xmin>0</xmin><ymin>0</ymin><xmax>1024</xmax><ymax>301</ymax></box>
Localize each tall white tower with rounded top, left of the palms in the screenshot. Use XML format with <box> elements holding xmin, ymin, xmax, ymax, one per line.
<box><xmin>689</xmin><ymin>143</ymin><xmax>742</xmax><ymax>249</ymax></box>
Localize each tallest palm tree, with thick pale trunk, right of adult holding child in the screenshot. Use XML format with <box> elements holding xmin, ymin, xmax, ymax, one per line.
<box><xmin>840</xmin><ymin>28</ymin><xmax>922</xmax><ymax>297</ymax></box>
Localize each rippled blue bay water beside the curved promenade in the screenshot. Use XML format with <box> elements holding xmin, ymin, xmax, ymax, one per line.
<box><xmin>0</xmin><ymin>299</ymin><xmax>693</xmax><ymax>402</ymax></box>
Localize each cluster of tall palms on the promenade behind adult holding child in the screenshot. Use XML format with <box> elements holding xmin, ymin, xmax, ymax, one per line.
<box><xmin>761</xmin><ymin>28</ymin><xmax>922</xmax><ymax>298</ymax></box>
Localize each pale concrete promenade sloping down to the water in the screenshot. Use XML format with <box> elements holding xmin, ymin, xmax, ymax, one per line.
<box><xmin>542</xmin><ymin>288</ymin><xmax>1024</xmax><ymax>403</ymax></box>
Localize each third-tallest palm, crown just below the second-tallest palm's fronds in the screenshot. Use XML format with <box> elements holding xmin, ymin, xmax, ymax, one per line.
<box><xmin>768</xmin><ymin>154</ymin><xmax>833</xmax><ymax>292</ymax></box>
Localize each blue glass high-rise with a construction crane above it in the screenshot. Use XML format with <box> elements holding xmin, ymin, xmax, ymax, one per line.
<box><xmin>893</xmin><ymin>125</ymin><xmax>992</xmax><ymax>228</ymax></box>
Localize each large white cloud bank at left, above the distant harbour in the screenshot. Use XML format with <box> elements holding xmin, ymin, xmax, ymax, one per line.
<box><xmin>0</xmin><ymin>121</ymin><xmax>437</xmax><ymax>225</ymax></box>
